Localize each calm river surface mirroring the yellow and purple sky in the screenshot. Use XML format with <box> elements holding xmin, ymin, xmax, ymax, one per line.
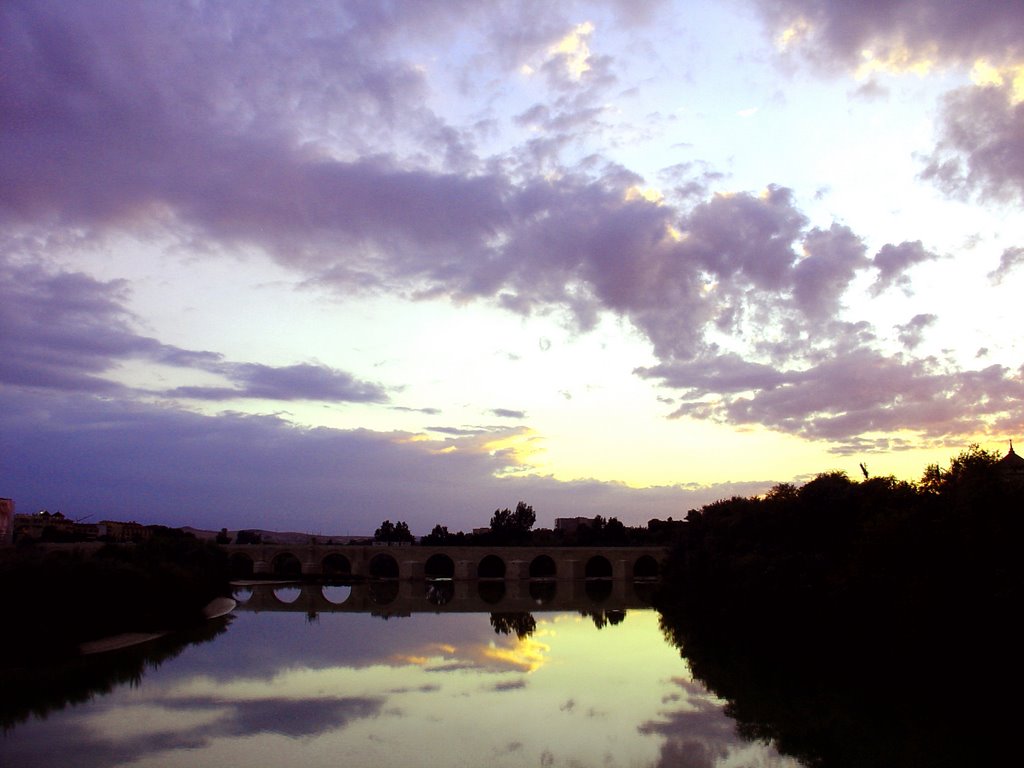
<box><xmin>0</xmin><ymin>587</ymin><xmax>797</xmax><ymax>768</ymax></box>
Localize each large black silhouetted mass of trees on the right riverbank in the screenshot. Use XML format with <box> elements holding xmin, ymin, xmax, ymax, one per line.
<box><xmin>657</xmin><ymin>447</ymin><xmax>1024</xmax><ymax>766</ymax></box>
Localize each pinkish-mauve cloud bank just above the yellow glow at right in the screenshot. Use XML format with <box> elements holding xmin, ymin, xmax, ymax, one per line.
<box><xmin>638</xmin><ymin>348</ymin><xmax>1024</xmax><ymax>449</ymax></box>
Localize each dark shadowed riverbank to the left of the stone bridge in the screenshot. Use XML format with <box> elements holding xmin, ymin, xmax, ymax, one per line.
<box><xmin>0</xmin><ymin>528</ymin><xmax>229</xmax><ymax>666</ymax></box>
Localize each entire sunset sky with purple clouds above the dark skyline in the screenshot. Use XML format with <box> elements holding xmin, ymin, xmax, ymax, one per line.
<box><xmin>0</xmin><ymin>0</ymin><xmax>1024</xmax><ymax>535</ymax></box>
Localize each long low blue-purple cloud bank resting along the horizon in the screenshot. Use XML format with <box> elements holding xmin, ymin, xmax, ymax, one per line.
<box><xmin>0</xmin><ymin>388</ymin><xmax>772</xmax><ymax>535</ymax></box>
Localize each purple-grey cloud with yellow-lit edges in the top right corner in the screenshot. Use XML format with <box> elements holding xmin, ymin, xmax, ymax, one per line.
<box><xmin>758</xmin><ymin>0</ymin><xmax>1024</xmax><ymax>210</ymax></box>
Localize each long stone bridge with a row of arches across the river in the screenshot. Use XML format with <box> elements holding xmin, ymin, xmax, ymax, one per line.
<box><xmin>225</xmin><ymin>544</ymin><xmax>668</xmax><ymax>581</ymax></box>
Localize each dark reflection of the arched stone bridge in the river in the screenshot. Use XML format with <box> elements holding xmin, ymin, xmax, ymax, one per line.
<box><xmin>234</xmin><ymin>579</ymin><xmax>656</xmax><ymax>615</ymax></box>
